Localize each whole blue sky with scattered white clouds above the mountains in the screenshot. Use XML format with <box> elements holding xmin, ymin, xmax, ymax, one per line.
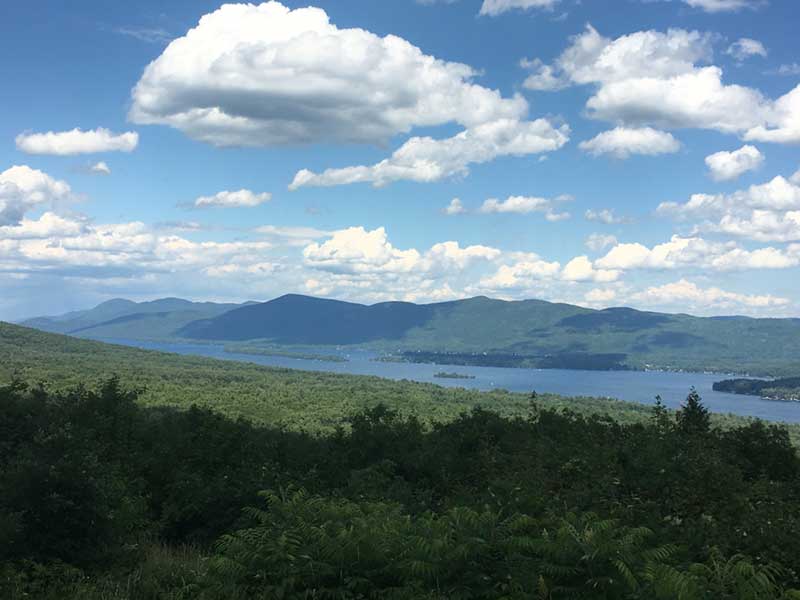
<box><xmin>0</xmin><ymin>0</ymin><xmax>800</xmax><ymax>320</ymax></box>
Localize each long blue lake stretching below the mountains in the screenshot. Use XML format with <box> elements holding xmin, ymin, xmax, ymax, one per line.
<box><xmin>103</xmin><ymin>339</ymin><xmax>800</xmax><ymax>423</ymax></box>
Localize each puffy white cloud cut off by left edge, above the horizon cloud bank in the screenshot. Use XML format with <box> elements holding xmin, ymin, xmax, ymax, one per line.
<box><xmin>0</xmin><ymin>165</ymin><xmax>72</xmax><ymax>225</ymax></box>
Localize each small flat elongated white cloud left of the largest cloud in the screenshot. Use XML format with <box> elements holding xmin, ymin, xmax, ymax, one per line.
<box><xmin>16</xmin><ymin>127</ymin><xmax>139</xmax><ymax>156</ymax></box>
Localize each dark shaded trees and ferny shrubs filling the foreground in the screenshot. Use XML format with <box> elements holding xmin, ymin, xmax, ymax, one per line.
<box><xmin>0</xmin><ymin>378</ymin><xmax>800</xmax><ymax>600</ymax></box>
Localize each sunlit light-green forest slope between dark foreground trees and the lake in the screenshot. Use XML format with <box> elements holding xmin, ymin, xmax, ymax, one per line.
<box><xmin>0</xmin><ymin>322</ymin><xmax>800</xmax><ymax>446</ymax></box>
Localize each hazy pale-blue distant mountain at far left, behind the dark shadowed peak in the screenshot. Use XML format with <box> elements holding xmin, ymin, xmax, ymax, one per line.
<box><xmin>21</xmin><ymin>298</ymin><xmax>253</xmax><ymax>339</ymax></box>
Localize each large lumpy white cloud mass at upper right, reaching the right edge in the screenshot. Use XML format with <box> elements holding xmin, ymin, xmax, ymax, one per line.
<box><xmin>527</xmin><ymin>25</ymin><xmax>800</xmax><ymax>143</ymax></box>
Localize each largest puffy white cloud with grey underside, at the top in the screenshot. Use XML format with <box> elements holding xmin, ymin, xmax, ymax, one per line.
<box><xmin>130</xmin><ymin>2</ymin><xmax>527</xmax><ymax>146</ymax></box>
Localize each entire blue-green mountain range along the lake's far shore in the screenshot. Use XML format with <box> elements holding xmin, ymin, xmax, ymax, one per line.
<box><xmin>22</xmin><ymin>294</ymin><xmax>800</xmax><ymax>375</ymax></box>
